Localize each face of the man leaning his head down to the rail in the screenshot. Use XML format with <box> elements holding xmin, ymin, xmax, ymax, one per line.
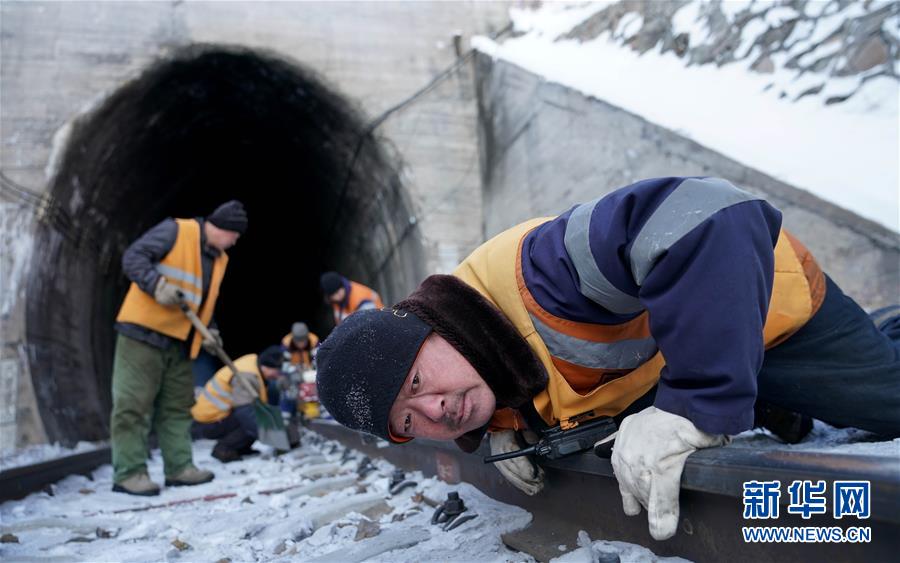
<box><xmin>390</xmin><ymin>333</ymin><xmax>496</xmax><ymax>440</ymax></box>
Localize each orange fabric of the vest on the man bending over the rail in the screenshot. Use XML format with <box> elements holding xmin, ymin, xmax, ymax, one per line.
<box><xmin>453</xmin><ymin>218</ymin><xmax>825</xmax><ymax>428</ymax></box>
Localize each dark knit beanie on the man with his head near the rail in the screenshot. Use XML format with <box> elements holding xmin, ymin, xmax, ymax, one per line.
<box><xmin>316</xmin><ymin>308</ymin><xmax>431</xmax><ymax>443</ymax></box>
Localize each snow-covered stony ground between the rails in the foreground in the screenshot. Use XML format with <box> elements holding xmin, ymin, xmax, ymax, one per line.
<box><xmin>0</xmin><ymin>433</ymin><xmax>683</xmax><ymax>563</ymax></box>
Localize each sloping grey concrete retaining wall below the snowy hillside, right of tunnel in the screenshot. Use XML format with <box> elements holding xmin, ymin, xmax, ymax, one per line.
<box><xmin>476</xmin><ymin>54</ymin><xmax>900</xmax><ymax>308</ymax></box>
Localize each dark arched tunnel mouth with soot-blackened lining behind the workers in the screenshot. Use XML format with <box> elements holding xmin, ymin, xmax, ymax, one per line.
<box><xmin>26</xmin><ymin>46</ymin><xmax>424</xmax><ymax>442</ymax></box>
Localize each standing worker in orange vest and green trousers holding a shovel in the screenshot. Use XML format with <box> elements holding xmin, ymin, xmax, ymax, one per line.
<box><xmin>110</xmin><ymin>200</ymin><xmax>247</xmax><ymax>496</ymax></box>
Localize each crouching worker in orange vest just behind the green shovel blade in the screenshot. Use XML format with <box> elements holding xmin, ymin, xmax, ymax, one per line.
<box><xmin>191</xmin><ymin>346</ymin><xmax>282</xmax><ymax>463</ymax></box>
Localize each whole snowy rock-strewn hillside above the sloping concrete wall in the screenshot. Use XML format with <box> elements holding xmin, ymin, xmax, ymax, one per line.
<box><xmin>473</xmin><ymin>0</ymin><xmax>900</xmax><ymax>231</ymax></box>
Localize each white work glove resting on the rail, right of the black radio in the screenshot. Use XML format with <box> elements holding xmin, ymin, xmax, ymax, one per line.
<box><xmin>612</xmin><ymin>407</ymin><xmax>731</xmax><ymax>540</ymax></box>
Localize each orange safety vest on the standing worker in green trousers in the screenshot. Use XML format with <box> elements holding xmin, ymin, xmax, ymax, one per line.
<box><xmin>116</xmin><ymin>219</ymin><xmax>228</xmax><ymax>359</ymax></box>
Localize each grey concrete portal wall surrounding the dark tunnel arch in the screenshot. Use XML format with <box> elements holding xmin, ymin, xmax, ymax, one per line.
<box><xmin>0</xmin><ymin>0</ymin><xmax>508</xmax><ymax>448</ymax></box>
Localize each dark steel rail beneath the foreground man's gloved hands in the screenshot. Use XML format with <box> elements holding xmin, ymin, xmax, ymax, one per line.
<box><xmin>310</xmin><ymin>420</ymin><xmax>900</xmax><ymax>562</ymax></box>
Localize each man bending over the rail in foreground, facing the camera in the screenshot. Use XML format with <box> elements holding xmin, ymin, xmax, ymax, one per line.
<box><xmin>318</xmin><ymin>178</ymin><xmax>900</xmax><ymax>539</ymax></box>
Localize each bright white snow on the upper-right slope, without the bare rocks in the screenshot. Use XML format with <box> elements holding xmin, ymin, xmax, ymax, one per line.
<box><xmin>472</xmin><ymin>2</ymin><xmax>900</xmax><ymax>231</ymax></box>
